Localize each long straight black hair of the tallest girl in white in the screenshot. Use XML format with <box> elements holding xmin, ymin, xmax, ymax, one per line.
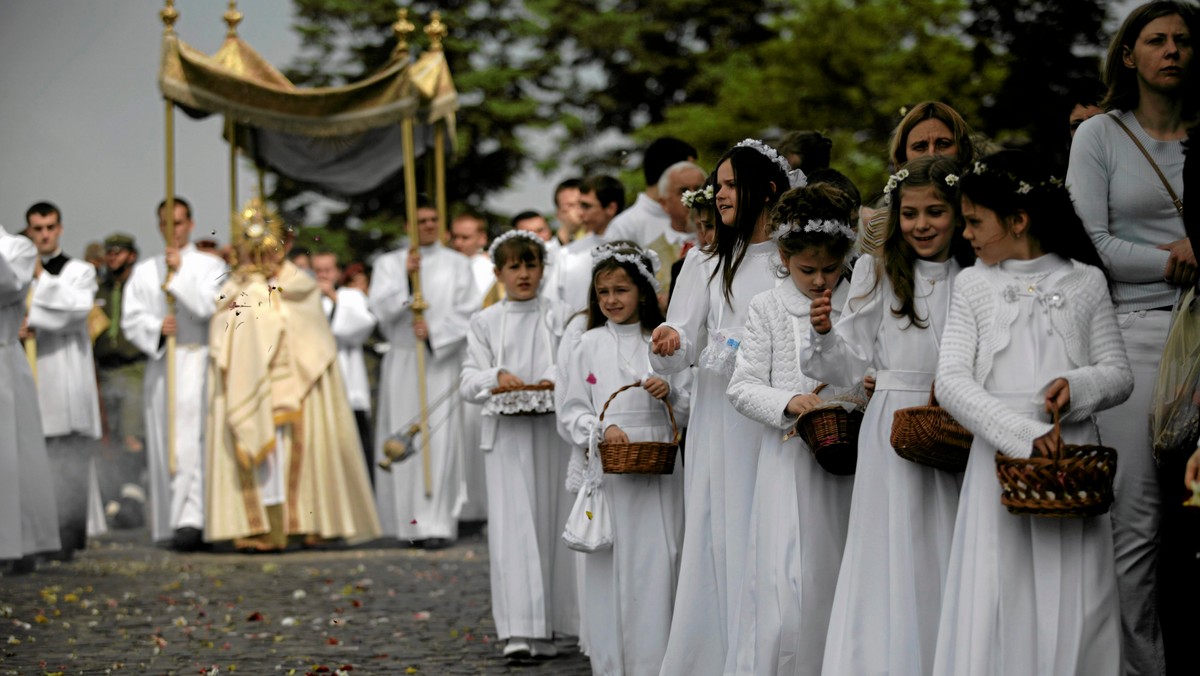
<box><xmin>709</xmin><ymin>146</ymin><xmax>787</xmax><ymax>304</ymax></box>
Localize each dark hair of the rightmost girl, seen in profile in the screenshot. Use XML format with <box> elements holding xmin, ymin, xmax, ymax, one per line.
<box><xmin>961</xmin><ymin>150</ymin><xmax>1108</xmax><ymax>279</ymax></box>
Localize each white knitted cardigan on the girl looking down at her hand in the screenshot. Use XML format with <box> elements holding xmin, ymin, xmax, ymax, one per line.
<box><xmin>727</xmin><ymin>279</ymin><xmax>850</xmax><ymax>430</ymax></box>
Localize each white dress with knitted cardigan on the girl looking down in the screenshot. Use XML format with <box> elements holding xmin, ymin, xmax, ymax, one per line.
<box><xmin>725</xmin><ymin>279</ymin><xmax>854</xmax><ymax>676</ymax></box>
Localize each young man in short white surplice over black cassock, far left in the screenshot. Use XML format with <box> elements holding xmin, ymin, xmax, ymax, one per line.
<box><xmin>22</xmin><ymin>202</ymin><xmax>101</xmax><ymax>561</ymax></box>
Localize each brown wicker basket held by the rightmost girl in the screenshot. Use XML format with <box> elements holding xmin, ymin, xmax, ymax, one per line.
<box><xmin>996</xmin><ymin>409</ymin><xmax>1117</xmax><ymax>518</ymax></box>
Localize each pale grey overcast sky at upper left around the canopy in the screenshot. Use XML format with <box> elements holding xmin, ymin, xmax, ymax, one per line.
<box><xmin>0</xmin><ymin>0</ymin><xmax>552</xmax><ymax>256</ymax></box>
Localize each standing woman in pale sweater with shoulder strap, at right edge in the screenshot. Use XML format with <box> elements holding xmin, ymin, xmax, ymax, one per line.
<box><xmin>1067</xmin><ymin>2</ymin><xmax>1198</xmax><ymax>674</ymax></box>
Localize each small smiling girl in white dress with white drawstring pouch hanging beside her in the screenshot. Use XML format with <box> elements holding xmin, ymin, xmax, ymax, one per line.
<box><xmin>558</xmin><ymin>243</ymin><xmax>690</xmax><ymax>676</ymax></box>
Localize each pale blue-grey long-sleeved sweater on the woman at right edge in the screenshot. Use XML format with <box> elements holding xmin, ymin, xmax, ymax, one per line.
<box><xmin>1067</xmin><ymin>110</ymin><xmax>1187</xmax><ymax>312</ymax></box>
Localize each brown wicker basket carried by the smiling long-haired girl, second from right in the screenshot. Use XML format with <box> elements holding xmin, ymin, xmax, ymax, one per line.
<box><xmin>892</xmin><ymin>385</ymin><xmax>974</xmax><ymax>472</ymax></box>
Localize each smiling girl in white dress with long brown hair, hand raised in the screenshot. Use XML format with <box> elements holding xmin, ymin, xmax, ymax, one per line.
<box><xmin>803</xmin><ymin>156</ymin><xmax>972</xmax><ymax>676</ymax></box>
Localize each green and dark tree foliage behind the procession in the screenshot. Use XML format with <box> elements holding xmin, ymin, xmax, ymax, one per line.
<box><xmin>281</xmin><ymin>0</ymin><xmax>1105</xmax><ymax>264</ymax></box>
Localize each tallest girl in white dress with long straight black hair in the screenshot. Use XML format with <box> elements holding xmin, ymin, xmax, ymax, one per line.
<box><xmin>650</xmin><ymin>139</ymin><xmax>803</xmax><ymax>676</ymax></box>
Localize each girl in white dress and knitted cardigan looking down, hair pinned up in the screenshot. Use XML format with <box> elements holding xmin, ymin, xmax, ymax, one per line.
<box><xmin>725</xmin><ymin>184</ymin><xmax>856</xmax><ymax>676</ymax></box>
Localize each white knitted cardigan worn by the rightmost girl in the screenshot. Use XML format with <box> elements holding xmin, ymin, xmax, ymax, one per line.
<box><xmin>937</xmin><ymin>262</ymin><xmax>1145</xmax><ymax>457</ymax></box>
